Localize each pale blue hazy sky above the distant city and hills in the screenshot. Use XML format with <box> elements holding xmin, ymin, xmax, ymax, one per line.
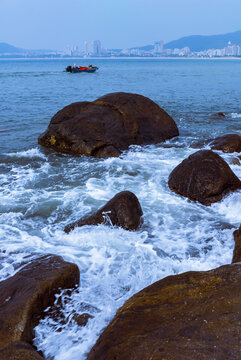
<box><xmin>0</xmin><ymin>0</ymin><xmax>241</xmax><ymax>50</ymax></box>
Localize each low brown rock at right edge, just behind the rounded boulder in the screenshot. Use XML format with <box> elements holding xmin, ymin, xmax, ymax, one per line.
<box><xmin>191</xmin><ymin>134</ymin><xmax>241</xmax><ymax>153</ymax></box>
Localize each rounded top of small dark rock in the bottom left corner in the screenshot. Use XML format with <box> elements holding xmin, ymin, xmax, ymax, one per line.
<box><xmin>0</xmin><ymin>341</ymin><xmax>44</xmax><ymax>360</ymax></box>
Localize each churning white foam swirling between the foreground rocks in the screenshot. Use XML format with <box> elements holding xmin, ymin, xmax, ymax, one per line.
<box><xmin>0</xmin><ymin>142</ymin><xmax>237</xmax><ymax>360</ymax></box>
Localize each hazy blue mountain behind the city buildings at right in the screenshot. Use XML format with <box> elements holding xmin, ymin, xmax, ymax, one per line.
<box><xmin>164</xmin><ymin>31</ymin><xmax>241</xmax><ymax>51</ymax></box>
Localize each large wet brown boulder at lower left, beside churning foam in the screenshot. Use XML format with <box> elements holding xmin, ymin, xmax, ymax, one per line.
<box><xmin>0</xmin><ymin>255</ymin><xmax>79</xmax><ymax>349</ymax></box>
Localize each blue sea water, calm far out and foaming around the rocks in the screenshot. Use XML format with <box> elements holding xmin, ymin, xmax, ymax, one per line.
<box><xmin>0</xmin><ymin>59</ymin><xmax>241</xmax><ymax>360</ymax></box>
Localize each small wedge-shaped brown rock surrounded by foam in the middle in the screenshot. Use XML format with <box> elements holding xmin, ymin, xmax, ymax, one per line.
<box><xmin>64</xmin><ymin>191</ymin><xmax>143</xmax><ymax>233</ymax></box>
